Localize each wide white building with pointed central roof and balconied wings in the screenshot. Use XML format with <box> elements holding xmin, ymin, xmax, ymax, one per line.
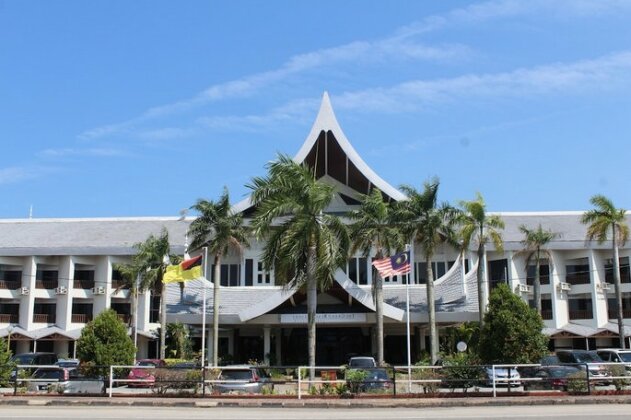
<box><xmin>0</xmin><ymin>94</ymin><xmax>631</xmax><ymax>364</ymax></box>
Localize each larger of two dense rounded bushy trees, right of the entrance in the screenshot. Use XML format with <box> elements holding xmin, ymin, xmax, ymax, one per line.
<box><xmin>478</xmin><ymin>284</ymin><xmax>548</xmax><ymax>364</ymax></box>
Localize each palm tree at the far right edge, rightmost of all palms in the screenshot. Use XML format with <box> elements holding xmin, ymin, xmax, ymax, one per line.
<box><xmin>581</xmin><ymin>194</ymin><xmax>629</xmax><ymax>349</ymax></box>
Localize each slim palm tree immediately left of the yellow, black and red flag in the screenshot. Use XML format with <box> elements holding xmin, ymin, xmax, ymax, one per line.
<box><xmin>132</xmin><ymin>229</ymin><xmax>175</xmax><ymax>359</ymax></box>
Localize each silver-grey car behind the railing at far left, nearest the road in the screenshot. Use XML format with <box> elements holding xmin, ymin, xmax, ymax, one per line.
<box><xmin>27</xmin><ymin>367</ymin><xmax>105</xmax><ymax>394</ymax></box>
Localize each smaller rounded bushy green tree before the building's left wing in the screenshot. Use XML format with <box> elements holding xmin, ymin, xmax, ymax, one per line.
<box><xmin>77</xmin><ymin>309</ymin><xmax>136</xmax><ymax>366</ymax></box>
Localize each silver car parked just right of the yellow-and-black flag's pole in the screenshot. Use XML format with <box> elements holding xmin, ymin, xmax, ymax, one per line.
<box><xmin>213</xmin><ymin>365</ymin><xmax>274</xmax><ymax>394</ymax></box>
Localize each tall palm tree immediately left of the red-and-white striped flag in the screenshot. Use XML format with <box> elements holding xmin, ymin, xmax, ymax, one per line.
<box><xmin>349</xmin><ymin>188</ymin><xmax>403</xmax><ymax>365</ymax></box>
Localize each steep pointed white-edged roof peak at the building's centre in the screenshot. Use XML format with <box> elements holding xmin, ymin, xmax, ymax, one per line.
<box><xmin>234</xmin><ymin>92</ymin><xmax>406</xmax><ymax>211</ymax></box>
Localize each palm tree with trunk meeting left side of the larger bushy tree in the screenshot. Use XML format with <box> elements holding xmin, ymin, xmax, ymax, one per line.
<box><xmin>459</xmin><ymin>193</ymin><xmax>504</xmax><ymax>327</ymax></box>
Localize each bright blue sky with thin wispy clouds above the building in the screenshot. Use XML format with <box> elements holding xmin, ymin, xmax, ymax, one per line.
<box><xmin>0</xmin><ymin>0</ymin><xmax>631</xmax><ymax>218</ymax></box>
